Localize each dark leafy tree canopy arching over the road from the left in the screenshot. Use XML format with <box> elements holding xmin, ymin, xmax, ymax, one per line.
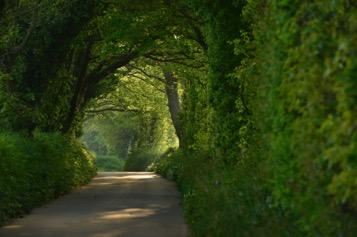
<box><xmin>1</xmin><ymin>0</ymin><xmax>204</xmax><ymax>146</ymax></box>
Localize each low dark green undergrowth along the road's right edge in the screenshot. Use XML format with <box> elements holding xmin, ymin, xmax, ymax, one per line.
<box><xmin>153</xmin><ymin>151</ymin><xmax>274</xmax><ymax>236</ymax></box>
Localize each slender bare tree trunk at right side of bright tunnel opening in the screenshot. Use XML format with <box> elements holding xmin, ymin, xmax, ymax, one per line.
<box><xmin>164</xmin><ymin>72</ymin><xmax>183</xmax><ymax>146</ymax></box>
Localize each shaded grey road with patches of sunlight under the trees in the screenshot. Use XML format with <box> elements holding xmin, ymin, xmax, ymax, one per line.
<box><xmin>0</xmin><ymin>172</ymin><xmax>187</xmax><ymax>237</ymax></box>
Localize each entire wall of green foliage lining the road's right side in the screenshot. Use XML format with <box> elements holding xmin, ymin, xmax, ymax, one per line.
<box><xmin>154</xmin><ymin>0</ymin><xmax>357</xmax><ymax>236</ymax></box>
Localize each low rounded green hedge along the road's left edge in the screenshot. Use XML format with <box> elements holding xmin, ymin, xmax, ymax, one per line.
<box><xmin>0</xmin><ymin>133</ymin><xmax>96</xmax><ymax>224</ymax></box>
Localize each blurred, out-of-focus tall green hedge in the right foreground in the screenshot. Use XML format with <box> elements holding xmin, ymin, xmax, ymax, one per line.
<box><xmin>252</xmin><ymin>1</ymin><xmax>357</xmax><ymax>236</ymax></box>
